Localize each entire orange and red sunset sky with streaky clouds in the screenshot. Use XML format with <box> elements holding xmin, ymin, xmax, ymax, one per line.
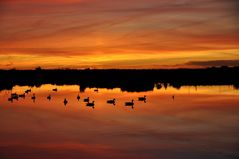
<box><xmin>0</xmin><ymin>0</ymin><xmax>239</xmax><ymax>69</ymax></box>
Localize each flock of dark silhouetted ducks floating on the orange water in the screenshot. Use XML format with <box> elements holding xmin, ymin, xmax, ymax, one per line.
<box><xmin>8</xmin><ymin>88</ymin><xmax>149</xmax><ymax>109</ymax></box>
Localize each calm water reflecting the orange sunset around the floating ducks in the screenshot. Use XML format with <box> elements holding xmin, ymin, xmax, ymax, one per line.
<box><xmin>0</xmin><ymin>85</ymin><xmax>239</xmax><ymax>159</ymax></box>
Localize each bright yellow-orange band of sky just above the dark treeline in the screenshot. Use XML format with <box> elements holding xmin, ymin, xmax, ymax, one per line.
<box><xmin>0</xmin><ymin>50</ymin><xmax>239</xmax><ymax>69</ymax></box>
